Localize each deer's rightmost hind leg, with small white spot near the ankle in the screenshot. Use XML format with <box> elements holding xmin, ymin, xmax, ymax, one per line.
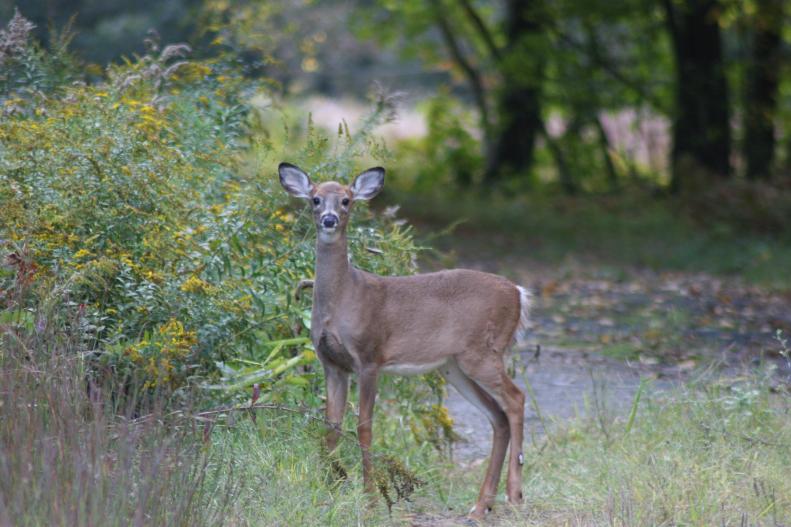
<box><xmin>459</xmin><ymin>355</ymin><xmax>525</xmax><ymax>504</ymax></box>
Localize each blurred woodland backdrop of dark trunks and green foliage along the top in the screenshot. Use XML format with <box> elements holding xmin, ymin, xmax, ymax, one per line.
<box><xmin>0</xmin><ymin>0</ymin><xmax>791</xmax><ymax>210</ymax></box>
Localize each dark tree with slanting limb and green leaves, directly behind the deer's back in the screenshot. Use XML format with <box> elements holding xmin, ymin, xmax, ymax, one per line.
<box><xmin>377</xmin><ymin>0</ymin><xmax>546</xmax><ymax>186</ymax></box>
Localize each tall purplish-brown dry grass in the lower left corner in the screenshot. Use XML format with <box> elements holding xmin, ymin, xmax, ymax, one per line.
<box><xmin>0</xmin><ymin>308</ymin><xmax>227</xmax><ymax>526</ymax></box>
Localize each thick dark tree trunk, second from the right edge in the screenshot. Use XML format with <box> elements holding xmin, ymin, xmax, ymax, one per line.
<box><xmin>663</xmin><ymin>0</ymin><xmax>731</xmax><ymax>192</ymax></box>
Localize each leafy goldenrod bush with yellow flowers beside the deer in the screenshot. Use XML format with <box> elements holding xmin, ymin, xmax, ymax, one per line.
<box><xmin>0</xmin><ymin>16</ymin><xmax>414</xmax><ymax>399</ymax></box>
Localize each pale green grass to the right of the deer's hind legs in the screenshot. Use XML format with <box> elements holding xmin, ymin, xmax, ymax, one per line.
<box><xmin>430</xmin><ymin>377</ymin><xmax>791</xmax><ymax>526</ymax></box>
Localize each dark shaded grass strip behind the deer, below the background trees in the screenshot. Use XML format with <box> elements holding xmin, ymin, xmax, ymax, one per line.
<box><xmin>388</xmin><ymin>190</ymin><xmax>791</xmax><ymax>289</ymax></box>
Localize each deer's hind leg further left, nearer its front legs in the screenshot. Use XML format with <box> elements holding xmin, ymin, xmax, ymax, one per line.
<box><xmin>440</xmin><ymin>359</ymin><xmax>510</xmax><ymax>518</ymax></box>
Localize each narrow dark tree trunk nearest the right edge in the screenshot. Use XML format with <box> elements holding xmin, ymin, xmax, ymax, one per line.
<box><xmin>743</xmin><ymin>0</ymin><xmax>783</xmax><ymax>180</ymax></box>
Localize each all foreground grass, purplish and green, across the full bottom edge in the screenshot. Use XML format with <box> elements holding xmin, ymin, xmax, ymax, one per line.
<box><xmin>0</xmin><ymin>320</ymin><xmax>791</xmax><ymax>526</ymax></box>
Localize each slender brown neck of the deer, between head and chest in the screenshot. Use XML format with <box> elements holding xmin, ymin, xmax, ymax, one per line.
<box><xmin>314</xmin><ymin>232</ymin><xmax>351</xmax><ymax>313</ymax></box>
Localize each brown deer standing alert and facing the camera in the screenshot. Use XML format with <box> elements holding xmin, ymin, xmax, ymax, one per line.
<box><xmin>278</xmin><ymin>163</ymin><xmax>530</xmax><ymax>519</ymax></box>
